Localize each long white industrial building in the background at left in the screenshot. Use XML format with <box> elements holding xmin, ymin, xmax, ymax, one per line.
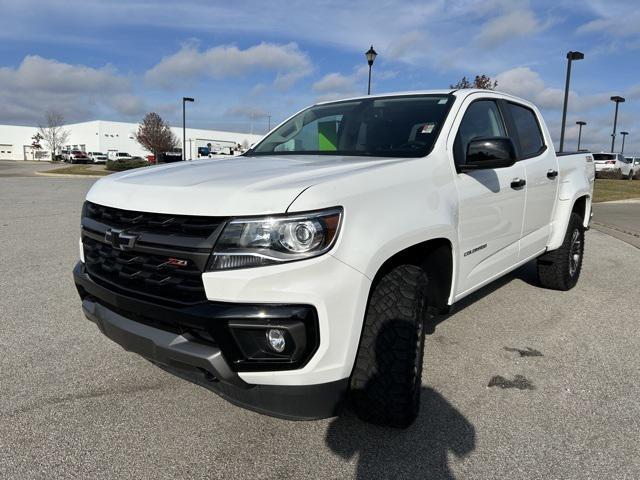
<box><xmin>0</xmin><ymin>120</ymin><xmax>261</xmax><ymax>160</ymax></box>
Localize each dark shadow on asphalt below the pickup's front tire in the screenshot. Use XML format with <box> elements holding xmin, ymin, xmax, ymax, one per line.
<box><xmin>326</xmin><ymin>387</ymin><xmax>476</xmax><ymax>480</ymax></box>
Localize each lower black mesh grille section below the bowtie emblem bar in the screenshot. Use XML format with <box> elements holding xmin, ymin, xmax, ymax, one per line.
<box><xmin>82</xmin><ymin>235</ymin><xmax>206</xmax><ymax>303</ymax></box>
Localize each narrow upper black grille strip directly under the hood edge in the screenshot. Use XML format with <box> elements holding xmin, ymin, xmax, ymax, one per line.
<box><xmin>85</xmin><ymin>202</ymin><xmax>223</xmax><ymax>238</ymax></box>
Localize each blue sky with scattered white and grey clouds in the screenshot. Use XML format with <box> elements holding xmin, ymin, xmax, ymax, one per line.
<box><xmin>0</xmin><ymin>0</ymin><xmax>640</xmax><ymax>155</ymax></box>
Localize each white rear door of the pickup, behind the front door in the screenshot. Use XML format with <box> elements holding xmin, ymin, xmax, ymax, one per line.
<box><xmin>502</xmin><ymin>101</ymin><xmax>559</xmax><ymax>260</ymax></box>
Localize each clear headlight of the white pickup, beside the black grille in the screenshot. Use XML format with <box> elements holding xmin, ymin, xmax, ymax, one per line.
<box><xmin>208</xmin><ymin>208</ymin><xmax>342</xmax><ymax>271</ymax></box>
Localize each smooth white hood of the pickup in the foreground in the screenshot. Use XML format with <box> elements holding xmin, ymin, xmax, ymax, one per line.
<box><xmin>87</xmin><ymin>155</ymin><xmax>403</xmax><ymax>216</ymax></box>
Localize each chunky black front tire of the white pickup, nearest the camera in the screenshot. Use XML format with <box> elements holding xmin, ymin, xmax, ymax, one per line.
<box><xmin>350</xmin><ymin>265</ymin><xmax>427</xmax><ymax>428</ymax></box>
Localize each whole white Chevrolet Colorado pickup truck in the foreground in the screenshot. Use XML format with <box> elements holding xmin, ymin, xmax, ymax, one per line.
<box><xmin>74</xmin><ymin>89</ymin><xmax>595</xmax><ymax>427</ymax></box>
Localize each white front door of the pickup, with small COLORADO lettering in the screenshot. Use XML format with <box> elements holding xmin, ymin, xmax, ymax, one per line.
<box><xmin>449</xmin><ymin>95</ymin><xmax>525</xmax><ymax>298</ymax></box>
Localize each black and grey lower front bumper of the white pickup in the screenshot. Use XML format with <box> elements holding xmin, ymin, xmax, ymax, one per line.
<box><xmin>73</xmin><ymin>263</ymin><xmax>348</xmax><ymax>420</ymax></box>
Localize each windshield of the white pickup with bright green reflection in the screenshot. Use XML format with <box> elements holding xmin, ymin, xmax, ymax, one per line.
<box><xmin>249</xmin><ymin>95</ymin><xmax>454</xmax><ymax>157</ymax></box>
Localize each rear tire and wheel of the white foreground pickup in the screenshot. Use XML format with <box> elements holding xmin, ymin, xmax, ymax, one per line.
<box><xmin>538</xmin><ymin>212</ymin><xmax>584</xmax><ymax>290</ymax></box>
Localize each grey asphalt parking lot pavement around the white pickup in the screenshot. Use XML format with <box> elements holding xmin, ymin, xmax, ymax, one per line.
<box><xmin>0</xmin><ymin>172</ymin><xmax>640</xmax><ymax>480</ymax></box>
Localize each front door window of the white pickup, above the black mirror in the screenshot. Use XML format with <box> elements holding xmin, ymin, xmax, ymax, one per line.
<box><xmin>454</xmin><ymin>100</ymin><xmax>506</xmax><ymax>165</ymax></box>
